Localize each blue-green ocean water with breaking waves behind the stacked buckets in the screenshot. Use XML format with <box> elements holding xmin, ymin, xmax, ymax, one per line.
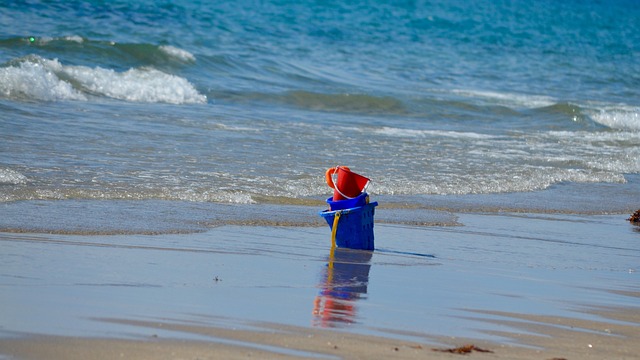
<box><xmin>0</xmin><ymin>0</ymin><xmax>640</xmax><ymax>232</ymax></box>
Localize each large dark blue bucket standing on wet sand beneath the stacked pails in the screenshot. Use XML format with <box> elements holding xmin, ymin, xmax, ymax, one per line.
<box><xmin>320</xmin><ymin>200</ymin><xmax>378</xmax><ymax>250</ymax></box>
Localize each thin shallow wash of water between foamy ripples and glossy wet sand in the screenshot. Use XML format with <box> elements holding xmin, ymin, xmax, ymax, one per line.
<box><xmin>0</xmin><ymin>174</ymin><xmax>640</xmax><ymax>236</ymax></box>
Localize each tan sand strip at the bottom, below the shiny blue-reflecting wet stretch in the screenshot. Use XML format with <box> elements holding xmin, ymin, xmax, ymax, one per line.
<box><xmin>0</xmin><ymin>309</ymin><xmax>640</xmax><ymax>360</ymax></box>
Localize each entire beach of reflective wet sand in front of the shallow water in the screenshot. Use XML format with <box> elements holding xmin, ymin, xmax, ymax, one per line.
<box><xmin>0</xmin><ymin>213</ymin><xmax>640</xmax><ymax>359</ymax></box>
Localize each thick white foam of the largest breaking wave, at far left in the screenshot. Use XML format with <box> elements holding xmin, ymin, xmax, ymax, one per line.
<box><xmin>0</xmin><ymin>56</ymin><xmax>207</xmax><ymax>104</ymax></box>
